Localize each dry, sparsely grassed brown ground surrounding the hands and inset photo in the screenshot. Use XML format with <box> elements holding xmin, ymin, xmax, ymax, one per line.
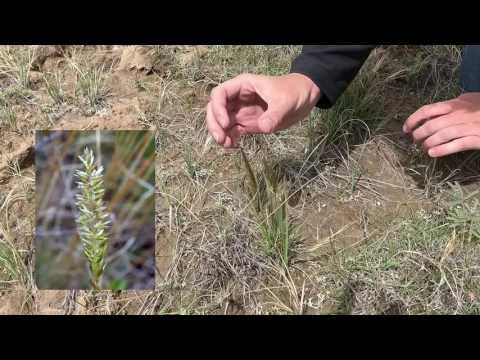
<box><xmin>0</xmin><ymin>46</ymin><xmax>480</xmax><ymax>314</ymax></box>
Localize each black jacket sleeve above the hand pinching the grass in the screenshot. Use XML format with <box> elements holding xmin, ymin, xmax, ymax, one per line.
<box><xmin>290</xmin><ymin>45</ymin><xmax>377</xmax><ymax>109</ymax></box>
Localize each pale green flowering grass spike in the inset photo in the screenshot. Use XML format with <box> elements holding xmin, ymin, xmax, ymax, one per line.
<box><xmin>76</xmin><ymin>148</ymin><xmax>109</xmax><ymax>290</ymax></box>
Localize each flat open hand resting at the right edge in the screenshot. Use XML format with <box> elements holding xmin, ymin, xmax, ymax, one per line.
<box><xmin>403</xmin><ymin>93</ymin><xmax>480</xmax><ymax>158</ymax></box>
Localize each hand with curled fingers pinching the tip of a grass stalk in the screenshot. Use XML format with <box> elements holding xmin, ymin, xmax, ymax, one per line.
<box><xmin>207</xmin><ymin>74</ymin><xmax>320</xmax><ymax>148</ymax></box>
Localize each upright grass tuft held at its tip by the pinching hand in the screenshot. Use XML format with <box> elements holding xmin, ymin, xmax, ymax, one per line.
<box><xmin>240</xmin><ymin>149</ymin><xmax>294</xmax><ymax>266</ymax></box>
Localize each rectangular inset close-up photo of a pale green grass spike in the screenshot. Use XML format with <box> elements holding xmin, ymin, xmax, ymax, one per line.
<box><xmin>35</xmin><ymin>130</ymin><xmax>155</xmax><ymax>290</ymax></box>
